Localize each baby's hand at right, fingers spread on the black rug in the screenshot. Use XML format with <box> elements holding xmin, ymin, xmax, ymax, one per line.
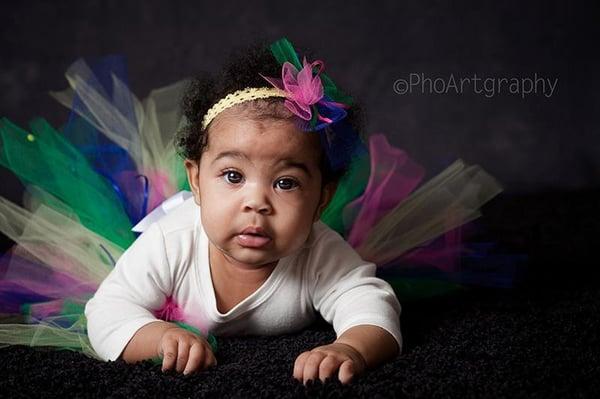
<box><xmin>294</xmin><ymin>342</ymin><xmax>366</xmax><ymax>384</ymax></box>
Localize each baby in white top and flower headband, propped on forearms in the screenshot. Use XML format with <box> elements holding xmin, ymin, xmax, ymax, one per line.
<box><xmin>85</xmin><ymin>42</ymin><xmax>402</xmax><ymax>383</ymax></box>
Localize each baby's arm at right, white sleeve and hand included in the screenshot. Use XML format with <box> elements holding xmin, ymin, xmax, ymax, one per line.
<box><xmin>294</xmin><ymin>225</ymin><xmax>402</xmax><ymax>383</ymax></box>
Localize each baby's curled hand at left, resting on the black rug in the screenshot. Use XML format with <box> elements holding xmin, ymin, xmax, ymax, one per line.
<box><xmin>158</xmin><ymin>327</ymin><xmax>217</xmax><ymax>375</ymax></box>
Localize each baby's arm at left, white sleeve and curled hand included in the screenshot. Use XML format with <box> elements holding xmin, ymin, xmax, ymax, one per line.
<box><xmin>85</xmin><ymin>224</ymin><xmax>214</xmax><ymax>371</ymax></box>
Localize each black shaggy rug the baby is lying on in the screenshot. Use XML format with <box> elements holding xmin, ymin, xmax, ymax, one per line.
<box><xmin>0</xmin><ymin>190</ymin><xmax>600</xmax><ymax>398</ymax></box>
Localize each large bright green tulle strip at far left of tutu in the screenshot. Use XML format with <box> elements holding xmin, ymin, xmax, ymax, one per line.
<box><xmin>0</xmin><ymin>118</ymin><xmax>135</xmax><ymax>248</ymax></box>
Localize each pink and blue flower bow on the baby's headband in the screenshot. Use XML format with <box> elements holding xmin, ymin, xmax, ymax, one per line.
<box><xmin>261</xmin><ymin>45</ymin><xmax>349</xmax><ymax>130</ymax></box>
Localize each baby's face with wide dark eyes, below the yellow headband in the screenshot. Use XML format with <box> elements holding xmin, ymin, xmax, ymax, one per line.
<box><xmin>186</xmin><ymin>112</ymin><xmax>332</xmax><ymax>268</ymax></box>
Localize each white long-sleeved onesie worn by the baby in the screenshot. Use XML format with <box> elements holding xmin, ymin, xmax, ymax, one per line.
<box><xmin>85</xmin><ymin>198</ymin><xmax>402</xmax><ymax>360</ymax></box>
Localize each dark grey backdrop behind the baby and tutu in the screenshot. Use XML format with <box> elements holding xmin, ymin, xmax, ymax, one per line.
<box><xmin>0</xmin><ymin>0</ymin><xmax>600</xmax><ymax>206</ymax></box>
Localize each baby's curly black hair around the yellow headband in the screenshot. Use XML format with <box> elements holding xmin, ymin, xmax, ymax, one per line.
<box><xmin>175</xmin><ymin>41</ymin><xmax>364</xmax><ymax>184</ymax></box>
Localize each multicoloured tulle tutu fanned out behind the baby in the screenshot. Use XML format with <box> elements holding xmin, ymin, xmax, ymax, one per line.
<box><xmin>0</xmin><ymin>57</ymin><xmax>517</xmax><ymax>359</ymax></box>
